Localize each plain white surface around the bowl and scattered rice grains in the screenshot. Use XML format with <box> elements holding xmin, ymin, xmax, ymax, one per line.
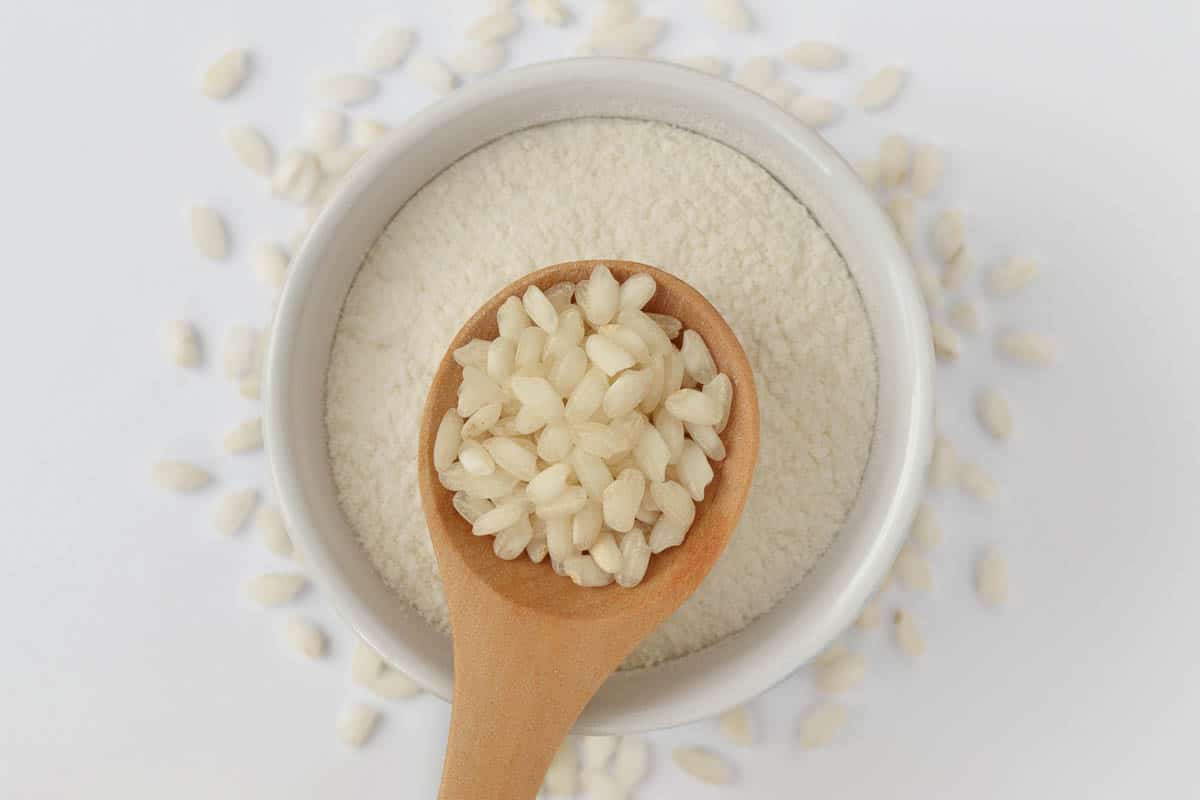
<box><xmin>0</xmin><ymin>0</ymin><xmax>1200</xmax><ymax>800</ymax></box>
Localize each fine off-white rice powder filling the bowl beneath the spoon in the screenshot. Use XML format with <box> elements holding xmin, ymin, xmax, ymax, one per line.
<box><xmin>326</xmin><ymin>119</ymin><xmax>876</xmax><ymax>667</ymax></box>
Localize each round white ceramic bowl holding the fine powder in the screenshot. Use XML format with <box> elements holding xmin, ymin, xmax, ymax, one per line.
<box><xmin>265</xmin><ymin>59</ymin><xmax>934</xmax><ymax>733</ymax></box>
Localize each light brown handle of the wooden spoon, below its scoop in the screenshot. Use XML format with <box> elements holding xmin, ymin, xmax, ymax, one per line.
<box><xmin>438</xmin><ymin>587</ymin><xmax>636</xmax><ymax>800</ymax></box>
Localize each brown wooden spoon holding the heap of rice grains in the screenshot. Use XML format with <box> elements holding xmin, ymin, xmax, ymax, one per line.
<box><xmin>418</xmin><ymin>260</ymin><xmax>758</xmax><ymax>800</ymax></box>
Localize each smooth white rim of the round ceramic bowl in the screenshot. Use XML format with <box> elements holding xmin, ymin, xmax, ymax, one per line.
<box><xmin>263</xmin><ymin>58</ymin><xmax>934</xmax><ymax>733</ymax></box>
